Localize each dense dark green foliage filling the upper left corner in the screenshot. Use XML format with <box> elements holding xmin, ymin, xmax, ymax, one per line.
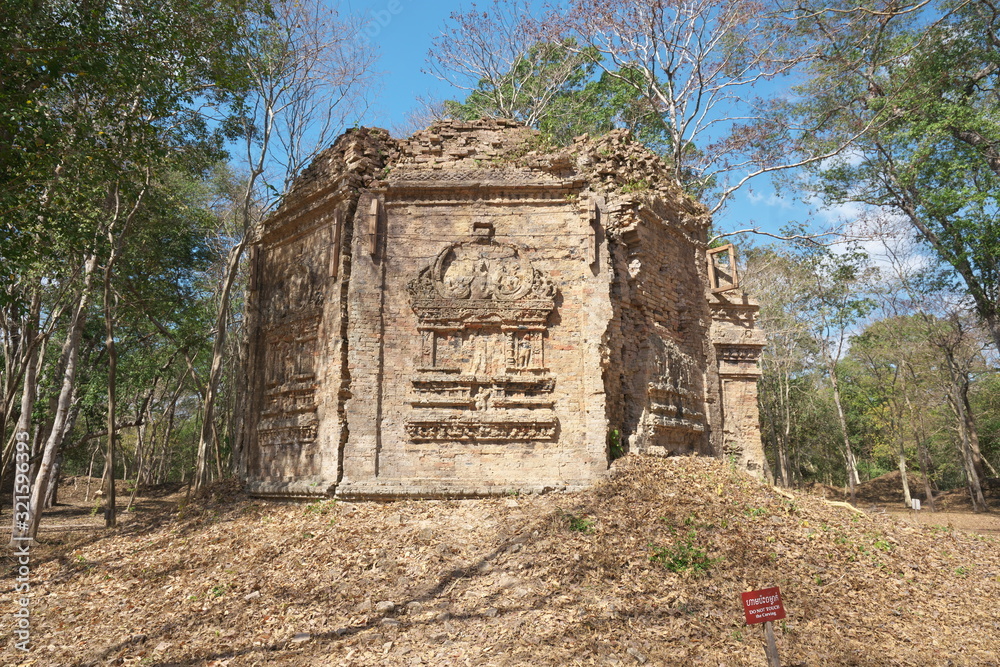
<box><xmin>0</xmin><ymin>0</ymin><xmax>269</xmax><ymax>291</ymax></box>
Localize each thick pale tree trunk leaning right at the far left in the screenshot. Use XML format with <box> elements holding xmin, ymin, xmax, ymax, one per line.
<box><xmin>11</xmin><ymin>255</ymin><xmax>97</xmax><ymax>543</ymax></box>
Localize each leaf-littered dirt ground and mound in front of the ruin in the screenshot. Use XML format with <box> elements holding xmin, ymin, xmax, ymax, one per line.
<box><xmin>0</xmin><ymin>456</ymin><xmax>1000</xmax><ymax>667</ymax></box>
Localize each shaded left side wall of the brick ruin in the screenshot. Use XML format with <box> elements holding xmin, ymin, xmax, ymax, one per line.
<box><xmin>241</xmin><ymin>130</ymin><xmax>391</xmax><ymax>496</ymax></box>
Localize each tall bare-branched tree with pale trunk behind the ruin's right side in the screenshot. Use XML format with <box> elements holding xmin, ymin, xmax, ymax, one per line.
<box><xmin>546</xmin><ymin>0</ymin><xmax>831</xmax><ymax>213</ymax></box>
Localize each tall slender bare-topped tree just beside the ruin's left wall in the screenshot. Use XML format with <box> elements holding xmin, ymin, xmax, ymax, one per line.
<box><xmin>193</xmin><ymin>0</ymin><xmax>375</xmax><ymax>492</ymax></box>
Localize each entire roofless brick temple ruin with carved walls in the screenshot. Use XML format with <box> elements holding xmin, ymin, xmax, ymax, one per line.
<box><xmin>241</xmin><ymin>120</ymin><xmax>765</xmax><ymax>498</ymax></box>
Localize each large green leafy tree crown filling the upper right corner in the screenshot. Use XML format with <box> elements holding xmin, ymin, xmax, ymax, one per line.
<box><xmin>790</xmin><ymin>0</ymin><xmax>1000</xmax><ymax>349</ymax></box>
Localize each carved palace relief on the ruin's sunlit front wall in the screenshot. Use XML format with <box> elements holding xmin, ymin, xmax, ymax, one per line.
<box><xmin>406</xmin><ymin>235</ymin><xmax>558</xmax><ymax>442</ymax></box>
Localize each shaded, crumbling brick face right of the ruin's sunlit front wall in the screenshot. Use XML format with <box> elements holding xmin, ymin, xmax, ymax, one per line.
<box><xmin>608</xmin><ymin>198</ymin><xmax>717</xmax><ymax>455</ymax></box>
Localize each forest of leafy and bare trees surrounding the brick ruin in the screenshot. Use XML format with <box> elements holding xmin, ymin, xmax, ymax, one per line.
<box><xmin>0</xmin><ymin>0</ymin><xmax>1000</xmax><ymax>535</ymax></box>
